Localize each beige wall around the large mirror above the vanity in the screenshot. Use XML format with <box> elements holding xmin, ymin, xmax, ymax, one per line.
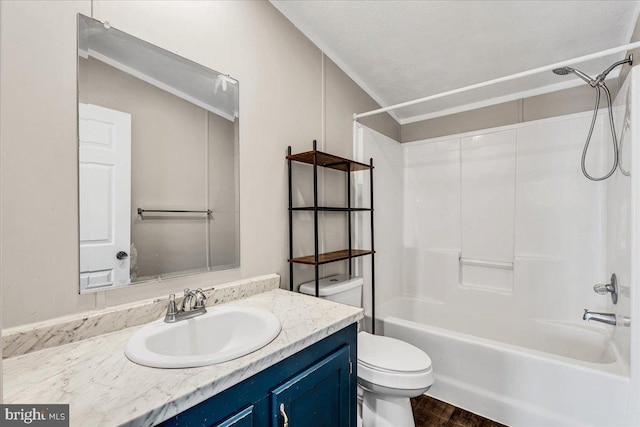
<box><xmin>0</xmin><ymin>0</ymin><xmax>399</xmax><ymax>327</ymax></box>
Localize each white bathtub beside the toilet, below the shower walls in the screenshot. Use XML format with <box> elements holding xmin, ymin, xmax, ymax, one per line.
<box><xmin>377</xmin><ymin>297</ymin><xmax>630</xmax><ymax>427</ymax></box>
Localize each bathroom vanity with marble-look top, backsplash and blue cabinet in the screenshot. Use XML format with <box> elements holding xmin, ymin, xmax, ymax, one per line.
<box><xmin>3</xmin><ymin>275</ymin><xmax>363</xmax><ymax>427</ymax></box>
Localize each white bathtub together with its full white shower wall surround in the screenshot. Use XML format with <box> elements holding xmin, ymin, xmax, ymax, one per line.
<box><xmin>356</xmin><ymin>67</ymin><xmax>640</xmax><ymax>427</ymax></box>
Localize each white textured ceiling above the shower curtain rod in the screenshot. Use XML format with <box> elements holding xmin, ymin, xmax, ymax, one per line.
<box><xmin>271</xmin><ymin>0</ymin><xmax>640</xmax><ymax>123</ymax></box>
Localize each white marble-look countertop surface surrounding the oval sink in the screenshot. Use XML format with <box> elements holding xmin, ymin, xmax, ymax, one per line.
<box><xmin>3</xmin><ymin>289</ymin><xmax>363</xmax><ymax>426</ymax></box>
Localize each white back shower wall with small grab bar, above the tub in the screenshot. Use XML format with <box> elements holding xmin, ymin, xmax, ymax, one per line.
<box><xmin>403</xmin><ymin>114</ymin><xmax>607</xmax><ymax>322</ymax></box>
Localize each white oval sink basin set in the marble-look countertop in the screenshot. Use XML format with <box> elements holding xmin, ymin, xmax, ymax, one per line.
<box><xmin>124</xmin><ymin>306</ymin><xmax>281</xmax><ymax>368</ymax></box>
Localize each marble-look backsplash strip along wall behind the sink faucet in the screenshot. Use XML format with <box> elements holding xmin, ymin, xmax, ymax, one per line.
<box><xmin>2</xmin><ymin>274</ymin><xmax>280</xmax><ymax>358</ymax></box>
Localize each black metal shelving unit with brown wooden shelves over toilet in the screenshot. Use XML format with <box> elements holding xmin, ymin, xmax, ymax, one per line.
<box><xmin>287</xmin><ymin>140</ymin><xmax>376</xmax><ymax>334</ymax></box>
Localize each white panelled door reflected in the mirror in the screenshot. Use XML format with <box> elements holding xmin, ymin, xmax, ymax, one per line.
<box><xmin>78</xmin><ymin>104</ymin><xmax>131</xmax><ymax>290</ymax></box>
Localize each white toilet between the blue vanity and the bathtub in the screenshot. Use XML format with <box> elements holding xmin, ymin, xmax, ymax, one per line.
<box><xmin>300</xmin><ymin>275</ymin><xmax>433</xmax><ymax>427</ymax></box>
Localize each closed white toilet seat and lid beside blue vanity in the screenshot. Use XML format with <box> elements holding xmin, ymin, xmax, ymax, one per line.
<box><xmin>358</xmin><ymin>332</ymin><xmax>433</xmax><ymax>390</ymax></box>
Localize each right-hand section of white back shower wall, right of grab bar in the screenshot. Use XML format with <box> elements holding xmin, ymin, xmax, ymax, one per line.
<box><xmin>515</xmin><ymin>115</ymin><xmax>607</xmax><ymax>322</ymax></box>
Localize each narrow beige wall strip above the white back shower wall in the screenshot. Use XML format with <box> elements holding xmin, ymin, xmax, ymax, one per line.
<box><xmin>400</xmin><ymin>79</ymin><xmax>619</xmax><ymax>142</ymax></box>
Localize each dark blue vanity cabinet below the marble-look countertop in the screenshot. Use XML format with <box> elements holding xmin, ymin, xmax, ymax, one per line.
<box><xmin>159</xmin><ymin>323</ymin><xmax>357</xmax><ymax>427</ymax></box>
